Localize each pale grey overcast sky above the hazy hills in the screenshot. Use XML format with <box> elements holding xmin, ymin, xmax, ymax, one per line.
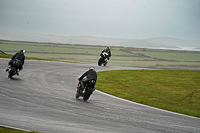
<box><xmin>0</xmin><ymin>0</ymin><xmax>200</xmax><ymax>40</ymax></box>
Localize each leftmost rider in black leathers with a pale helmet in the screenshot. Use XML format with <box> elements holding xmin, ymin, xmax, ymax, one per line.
<box><xmin>6</xmin><ymin>50</ymin><xmax>25</xmax><ymax>75</ymax></box>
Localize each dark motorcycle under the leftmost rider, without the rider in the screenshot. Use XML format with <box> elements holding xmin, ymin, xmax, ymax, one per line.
<box><xmin>8</xmin><ymin>59</ymin><xmax>21</xmax><ymax>79</ymax></box>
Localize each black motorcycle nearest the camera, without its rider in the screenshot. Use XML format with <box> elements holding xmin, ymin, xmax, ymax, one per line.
<box><xmin>76</xmin><ymin>79</ymin><xmax>96</xmax><ymax>101</ymax></box>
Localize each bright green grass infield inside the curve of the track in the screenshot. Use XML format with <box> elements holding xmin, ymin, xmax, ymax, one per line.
<box><xmin>96</xmin><ymin>70</ymin><xmax>200</xmax><ymax>117</ymax></box>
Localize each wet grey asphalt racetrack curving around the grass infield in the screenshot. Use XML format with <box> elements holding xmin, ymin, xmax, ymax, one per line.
<box><xmin>0</xmin><ymin>59</ymin><xmax>200</xmax><ymax>133</ymax></box>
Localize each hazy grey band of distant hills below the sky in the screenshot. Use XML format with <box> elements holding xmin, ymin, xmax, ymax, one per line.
<box><xmin>0</xmin><ymin>31</ymin><xmax>200</xmax><ymax>51</ymax></box>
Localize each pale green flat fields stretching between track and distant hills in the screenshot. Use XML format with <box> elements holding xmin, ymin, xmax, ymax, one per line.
<box><xmin>0</xmin><ymin>40</ymin><xmax>200</xmax><ymax>70</ymax></box>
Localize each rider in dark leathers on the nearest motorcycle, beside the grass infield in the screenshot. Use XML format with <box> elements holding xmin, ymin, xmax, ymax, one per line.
<box><xmin>77</xmin><ymin>66</ymin><xmax>97</xmax><ymax>91</ymax></box>
